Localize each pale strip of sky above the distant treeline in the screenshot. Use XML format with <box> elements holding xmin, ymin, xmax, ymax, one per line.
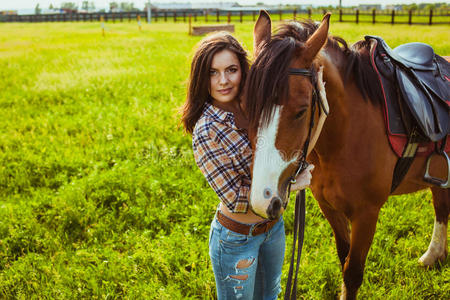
<box><xmin>0</xmin><ymin>0</ymin><xmax>446</xmax><ymax>10</ymax></box>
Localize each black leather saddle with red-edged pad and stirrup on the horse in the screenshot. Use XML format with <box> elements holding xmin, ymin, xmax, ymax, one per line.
<box><xmin>365</xmin><ymin>36</ymin><xmax>450</xmax><ymax>192</ymax></box>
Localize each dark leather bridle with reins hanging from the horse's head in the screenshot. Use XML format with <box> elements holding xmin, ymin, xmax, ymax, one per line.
<box><xmin>283</xmin><ymin>66</ymin><xmax>329</xmax><ymax>300</ymax></box>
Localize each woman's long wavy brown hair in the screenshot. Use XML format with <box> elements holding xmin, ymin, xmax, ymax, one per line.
<box><xmin>181</xmin><ymin>31</ymin><xmax>249</xmax><ymax>134</ymax></box>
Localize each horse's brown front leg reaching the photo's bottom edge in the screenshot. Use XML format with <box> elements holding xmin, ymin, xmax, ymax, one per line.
<box><xmin>341</xmin><ymin>206</ymin><xmax>380</xmax><ymax>300</ymax></box>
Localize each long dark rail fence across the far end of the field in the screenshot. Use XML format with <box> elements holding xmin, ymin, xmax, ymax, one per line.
<box><xmin>0</xmin><ymin>9</ymin><xmax>450</xmax><ymax>25</ymax></box>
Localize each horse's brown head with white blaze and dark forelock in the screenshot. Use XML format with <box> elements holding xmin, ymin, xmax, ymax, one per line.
<box><xmin>245</xmin><ymin>11</ymin><xmax>330</xmax><ymax>219</ymax></box>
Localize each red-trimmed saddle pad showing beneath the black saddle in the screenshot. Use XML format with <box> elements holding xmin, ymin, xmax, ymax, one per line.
<box><xmin>370</xmin><ymin>40</ymin><xmax>450</xmax><ymax>157</ymax></box>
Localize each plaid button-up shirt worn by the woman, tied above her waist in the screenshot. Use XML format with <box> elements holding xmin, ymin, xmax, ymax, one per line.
<box><xmin>192</xmin><ymin>103</ymin><xmax>252</xmax><ymax>213</ymax></box>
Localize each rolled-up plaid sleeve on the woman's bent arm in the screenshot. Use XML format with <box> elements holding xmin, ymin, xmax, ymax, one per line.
<box><xmin>192</xmin><ymin>134</ymin><xmax>250</xmax><ymax>213</ymax></box>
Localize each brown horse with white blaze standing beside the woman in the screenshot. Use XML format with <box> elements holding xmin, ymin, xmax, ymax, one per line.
<box><xmin>244</xmin><ymin>12</ymin><xmax>450</xmax><ymax>299</ymax></box>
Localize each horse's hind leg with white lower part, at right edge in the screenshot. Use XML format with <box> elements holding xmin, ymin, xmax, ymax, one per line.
<box><xmin>419</xmin><ymin>187</ymin><xmax>450</xmax><ymax>267</ymax></box>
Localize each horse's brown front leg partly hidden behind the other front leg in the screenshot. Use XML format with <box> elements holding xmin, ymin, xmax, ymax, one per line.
<box><xmin>319</xmin><ymin>201</ymin><xmax>350</xmax><ymax>268</ymax></box>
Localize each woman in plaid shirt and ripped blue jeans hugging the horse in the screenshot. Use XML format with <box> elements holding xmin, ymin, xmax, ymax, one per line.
<box><xmin>182</xmin><ymin>32</ymin><xmax>312</xmax><ymax>299</ymax></box>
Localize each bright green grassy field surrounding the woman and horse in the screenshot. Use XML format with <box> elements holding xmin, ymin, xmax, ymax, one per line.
<box><xmin>0</xmin><ymin>17</ymin><xmax>450</xmax><ymax>299</ymax></box>
